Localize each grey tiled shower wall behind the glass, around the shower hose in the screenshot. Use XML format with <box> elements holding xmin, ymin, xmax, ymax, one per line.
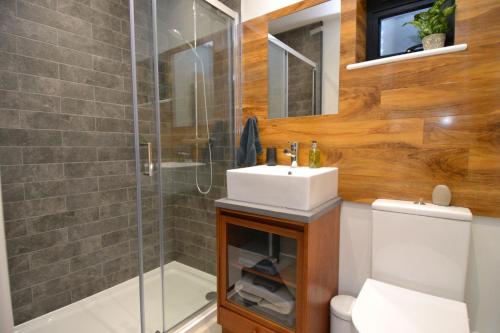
<box><xmin>162</xmin><ymin>26</ymin><xmax>234</xmax><ymax>274</ymax></box>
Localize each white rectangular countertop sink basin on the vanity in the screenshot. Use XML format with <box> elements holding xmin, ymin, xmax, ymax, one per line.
<box><xmin>227</xmin><ymin>165</ymin><xmax>338</xmax><ymax>210</ymax></box>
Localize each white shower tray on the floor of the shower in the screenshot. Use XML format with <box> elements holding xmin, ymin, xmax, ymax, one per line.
<box><xmin>14</xmin><ymin>261</ymin><xmax>217</xmax><ymax>333</ymax></box>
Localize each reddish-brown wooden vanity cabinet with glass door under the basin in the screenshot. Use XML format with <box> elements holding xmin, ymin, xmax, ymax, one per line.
<box><xmin>217</xmin><ymin>199</ymin><xmax>341</xmax><ymax>333</ymax></box>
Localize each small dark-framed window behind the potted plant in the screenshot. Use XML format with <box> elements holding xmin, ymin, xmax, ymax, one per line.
<box><xmin>366</xmin><ymin>0</ymin><xmax>455</xmax><ymax>60</ymax></box>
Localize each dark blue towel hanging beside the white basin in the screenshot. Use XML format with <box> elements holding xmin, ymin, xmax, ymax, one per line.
<box><xmin>236</xmin><ymin>117</ymin><xmax>262</xmax><ymax>166</ymax></box>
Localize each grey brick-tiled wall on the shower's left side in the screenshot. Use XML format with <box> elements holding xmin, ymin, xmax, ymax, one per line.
<box><xmin>0</xmin><ymin>0</ymin><xmax>158</xmax><ymax>323</ymax></box>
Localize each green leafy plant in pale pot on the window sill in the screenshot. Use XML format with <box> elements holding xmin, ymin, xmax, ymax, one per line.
<box><xmin>404</xmin><ymin>0</ymin><xmax>456</xmax><ymax>50</ymax></box>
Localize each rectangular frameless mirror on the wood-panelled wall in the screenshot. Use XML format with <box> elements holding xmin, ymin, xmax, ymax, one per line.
<box><xmin>268</xmin><ymin>0</ymin><xmax>340</xmax><ymax>119</ymax></box>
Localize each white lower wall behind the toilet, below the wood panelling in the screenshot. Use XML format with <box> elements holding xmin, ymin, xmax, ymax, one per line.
<box><xmin>339</xmin><ymin>202</ymin><xmax>500</xmax><ymax>333</ymax></box>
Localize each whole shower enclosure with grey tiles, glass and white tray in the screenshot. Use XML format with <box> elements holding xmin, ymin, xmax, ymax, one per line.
<box><xmin>0</xmin><ymin>0</ymin><xmax>240</xmax><ymax>333</ymax></box>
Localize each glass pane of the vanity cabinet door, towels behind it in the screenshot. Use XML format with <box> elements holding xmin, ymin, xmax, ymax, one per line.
<box><xmin>226</xmin><ymin>223</ymin><xmax>298</xmax><ymax>330</ymax></box>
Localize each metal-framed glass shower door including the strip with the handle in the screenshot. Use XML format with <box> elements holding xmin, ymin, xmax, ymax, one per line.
<box><xmin>132</xmin><ymin>0</ymin><xmax>238</xmax><ymax>332</ymax></box>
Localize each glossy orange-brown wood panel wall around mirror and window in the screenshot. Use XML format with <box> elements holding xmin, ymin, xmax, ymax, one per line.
<box><xmin>243</xmin><ymin>0</ymin><xmax>500</xmax><ymax>217</ymax></box>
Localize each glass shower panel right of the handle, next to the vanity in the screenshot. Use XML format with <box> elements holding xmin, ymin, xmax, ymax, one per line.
<box><xmin>157</xmin><ymin>0</ymin><xmax>235</xmax><ymax>329</ymax></box>
